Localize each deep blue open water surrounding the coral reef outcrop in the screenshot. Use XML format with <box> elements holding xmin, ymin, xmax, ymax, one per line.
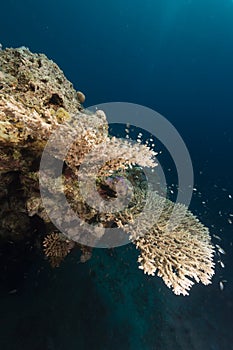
<box><xmin>0</xmin><ymin>0</ymin><xmax>233</xmax><ymax>350</ymax></box>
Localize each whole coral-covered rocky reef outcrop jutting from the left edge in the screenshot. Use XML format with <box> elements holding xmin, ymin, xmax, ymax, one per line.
<box><xmin>0</xmin><ymin>47</ymin><xmax>214</xmax><ymax>295</ymax></box>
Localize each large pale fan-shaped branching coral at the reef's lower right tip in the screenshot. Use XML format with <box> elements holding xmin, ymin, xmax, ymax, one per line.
<box><xmin>130</xmin><ymin>194</ymin><xmax>214</xmax><ymax>295</ymax></box>
